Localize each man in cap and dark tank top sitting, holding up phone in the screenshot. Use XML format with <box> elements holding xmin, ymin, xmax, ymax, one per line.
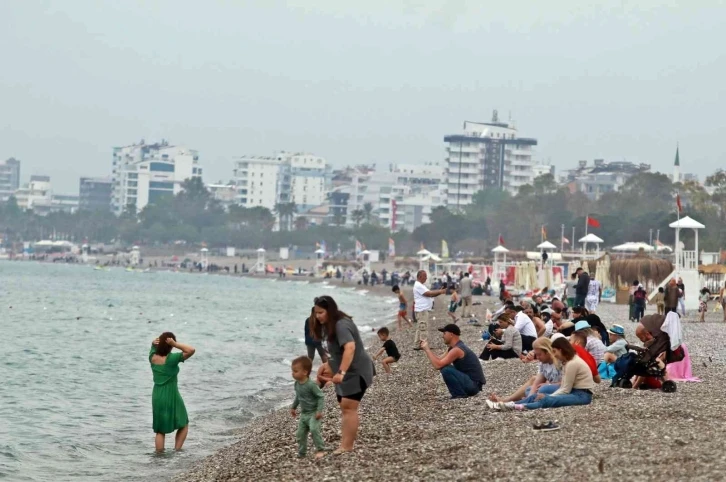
<box><xmin>421</xmin><ymin>323</ymin><xmax>486</xmax><ymax>398</ymax></box>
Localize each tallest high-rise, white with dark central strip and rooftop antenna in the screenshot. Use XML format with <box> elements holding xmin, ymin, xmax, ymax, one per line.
<box><xmin>444</xmin><ymin>111</ymin><xmax>537</xmax><ymax>208</ymax></box>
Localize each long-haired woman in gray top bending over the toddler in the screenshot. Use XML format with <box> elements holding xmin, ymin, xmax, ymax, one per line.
<box><xmin>311</xmin><ymin>295</ymin><xmax>375</xmax><ymax>455</ymax></box>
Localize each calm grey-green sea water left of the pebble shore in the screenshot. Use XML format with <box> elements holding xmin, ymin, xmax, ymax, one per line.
<box><xmin>0</xmin><ymin>262</ymin><xmax>395</xmax><ymax>481</ymax></box>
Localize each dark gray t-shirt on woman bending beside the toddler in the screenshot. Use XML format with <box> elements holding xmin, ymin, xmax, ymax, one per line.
<box><xmin>328</xmin><ymin>318</ymin><xmax>375</xmax><ymax>397</ymax></box>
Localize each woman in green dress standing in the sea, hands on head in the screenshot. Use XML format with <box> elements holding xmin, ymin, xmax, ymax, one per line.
<box><xmin>149</xmin><ymin>331</ymin><xmax>194</xmax><ymax>452</ymax></box>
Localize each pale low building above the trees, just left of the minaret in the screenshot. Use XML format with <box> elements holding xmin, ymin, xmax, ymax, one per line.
<box><xmin>560</xmin><ymin>159</ymin><xmax>650</xmax><ymax>201</ymax></box>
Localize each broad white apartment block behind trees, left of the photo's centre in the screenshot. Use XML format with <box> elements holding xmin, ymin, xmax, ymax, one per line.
<box><xmin>233</xmin><ymin>151</ymin><xmax>330</xmax><ymax>213</ymax></box>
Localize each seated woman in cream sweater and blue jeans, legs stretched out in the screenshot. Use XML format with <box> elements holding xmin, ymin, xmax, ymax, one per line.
<box><xmin>487</xmin><ymin>338</ymin><xmax>595</xmax><ymax>410</ymax></box>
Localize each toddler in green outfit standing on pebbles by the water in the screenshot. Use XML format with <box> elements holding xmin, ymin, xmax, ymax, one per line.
<box><xmin>290</xmin><ymin>356</ymin><xmax>326</xmax><ymax>459</ymax></box>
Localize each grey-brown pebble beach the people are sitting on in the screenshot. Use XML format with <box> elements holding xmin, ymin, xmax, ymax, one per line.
<box><xmin>173</xmin><ymin>287</ymin><xmax>726</xmax><ymax>482</ymax></box>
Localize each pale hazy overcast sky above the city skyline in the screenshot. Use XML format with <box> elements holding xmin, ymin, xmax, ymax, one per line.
<box><xmin>0</xmin><ymin>0</ymin><xmax>726</xmax><ymax>193</ymax></box>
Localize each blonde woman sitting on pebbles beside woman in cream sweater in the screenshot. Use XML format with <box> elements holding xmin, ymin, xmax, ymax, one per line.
<box><xmin>489</xmin><ymin>338</ymin><xmax>562</xmax><ymax>403</ymax></box>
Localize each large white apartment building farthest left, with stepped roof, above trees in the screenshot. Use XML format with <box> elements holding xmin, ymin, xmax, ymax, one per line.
<box><xmin>111</xmin><ymin>140</ymin><xmax>202</xmax><ymax>215</ymax></box>
